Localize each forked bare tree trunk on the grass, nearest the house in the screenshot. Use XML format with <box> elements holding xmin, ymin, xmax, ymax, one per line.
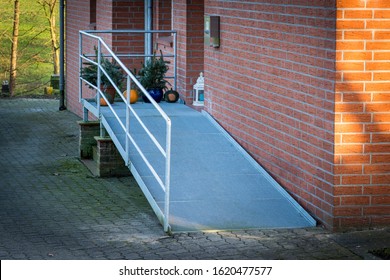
<box><xmin>38</xmin><ymin>0</ymin><xmax>60</xmax><ymax>74</ymax></box>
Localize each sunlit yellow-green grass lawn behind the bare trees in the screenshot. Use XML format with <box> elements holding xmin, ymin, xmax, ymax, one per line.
<box><xmin>0</xmin><ymin>0</ymin><xmax>58</xmax><ymax>95</ymax></box>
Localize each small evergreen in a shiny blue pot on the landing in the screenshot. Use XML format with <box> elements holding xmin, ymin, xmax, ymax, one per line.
<box><xmin>138</xmin><ymin>51</ymin><xmax>169</xmax><ymax>102</ymax></box>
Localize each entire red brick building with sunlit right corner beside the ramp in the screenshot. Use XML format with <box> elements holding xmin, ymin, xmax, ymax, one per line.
<box><xmin>66</xmin><ymin>0</ymin><xmax>390</xmax><ymax>230</ymax></box>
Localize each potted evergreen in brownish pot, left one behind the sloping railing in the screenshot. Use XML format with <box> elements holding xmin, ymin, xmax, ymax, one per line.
<box><xmin>81</xmin><ymin>47</ymin><xmax>125</xmax><ymax>103</ymax></box>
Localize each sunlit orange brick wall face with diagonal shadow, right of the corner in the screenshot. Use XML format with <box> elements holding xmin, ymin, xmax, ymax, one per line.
<box><xmin>334</xmin><ymin>0</ymin><xmax>390</xmax><ymax>228</ymax></box>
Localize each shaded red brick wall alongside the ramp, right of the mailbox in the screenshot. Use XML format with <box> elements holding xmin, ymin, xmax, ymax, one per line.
<box><xmin>204</xmin><ymin>0</ymin><xmax>336</xmax><ymax>227</ymax></box>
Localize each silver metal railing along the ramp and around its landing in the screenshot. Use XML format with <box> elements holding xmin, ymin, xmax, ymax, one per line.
<box><xmin>79</xmin><ymin>30</ymin><xmax>176</xmax><ymax>231</ymax></box>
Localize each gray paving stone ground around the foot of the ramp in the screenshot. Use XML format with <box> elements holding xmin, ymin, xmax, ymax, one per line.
<box><xmin>0</xmin><ymin>98</ymin><xmax>390</xmax><ymax>260</ymax></box>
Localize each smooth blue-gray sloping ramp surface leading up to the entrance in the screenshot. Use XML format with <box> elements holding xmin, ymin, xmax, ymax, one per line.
<box><xmin>98</xmin><ymin>102</ymin><xmax>315</xmax><ymax>232</ymax></box>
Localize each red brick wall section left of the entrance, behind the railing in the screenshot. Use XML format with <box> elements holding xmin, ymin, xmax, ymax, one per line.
<box><xmin>66</xmin><ymin>0</ymin><xmax>144</xmax><ymax>116</ymax></box>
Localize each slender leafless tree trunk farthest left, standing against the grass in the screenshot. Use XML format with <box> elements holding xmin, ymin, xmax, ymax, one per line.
<box><xmin>9</xmin><ymin>0</ymin><xmax>20</xmax><ymax>96</ymax></box>
